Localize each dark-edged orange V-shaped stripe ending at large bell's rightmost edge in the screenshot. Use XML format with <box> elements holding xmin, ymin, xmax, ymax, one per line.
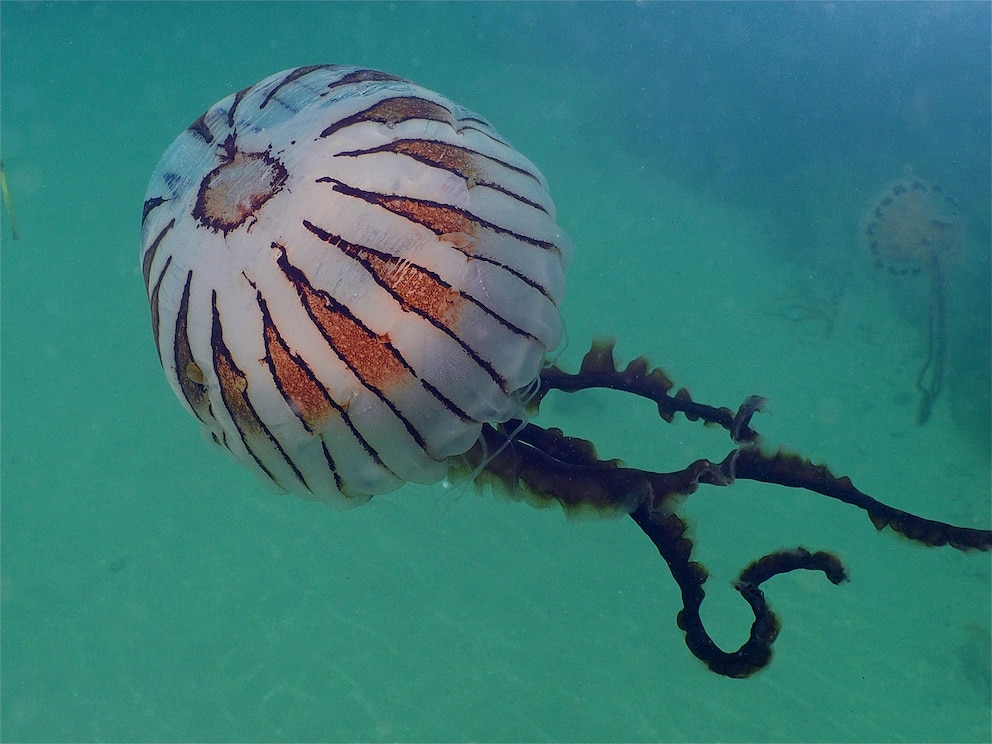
<box><xmin>317</xmin><ymin>176</ymin><xmax>561</xmax><ymax>299</ymax></box>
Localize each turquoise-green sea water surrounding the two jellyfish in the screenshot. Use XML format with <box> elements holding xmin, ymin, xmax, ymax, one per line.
<box><xmin>0</xmin><ymin>2</ymin><xmax>992</xmax><ymax>742</ymax></box>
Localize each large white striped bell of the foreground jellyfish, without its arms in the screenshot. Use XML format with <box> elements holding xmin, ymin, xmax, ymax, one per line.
<box><xmin>142</xmin><ymin>66</ymin><xmax>571</xmax><ymax>507</ymax></box>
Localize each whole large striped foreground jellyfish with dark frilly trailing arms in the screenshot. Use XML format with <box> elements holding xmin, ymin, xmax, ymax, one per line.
<box><xmin>141</xmin><ymin>65</ymin><xmax>992</xmax><ymax>677</ymax></box>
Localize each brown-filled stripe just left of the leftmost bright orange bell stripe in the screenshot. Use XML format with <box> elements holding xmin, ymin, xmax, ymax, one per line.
<box><xmin>210</xmin><ymin>290</ymin><xmax>310</xmax><ymax>490</ymax></box>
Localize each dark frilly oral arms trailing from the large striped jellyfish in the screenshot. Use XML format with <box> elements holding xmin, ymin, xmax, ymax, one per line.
<box><xmin>462</xmin><ymin>340</ymin><xmax>992</xmax><ymax>678</ymax></box>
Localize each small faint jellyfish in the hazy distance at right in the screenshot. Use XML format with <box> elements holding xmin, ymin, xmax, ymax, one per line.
<box><xmin>861</xmin><ymin>177</ymin><xmax>961</xmax><ymax>426</ymax></box>
